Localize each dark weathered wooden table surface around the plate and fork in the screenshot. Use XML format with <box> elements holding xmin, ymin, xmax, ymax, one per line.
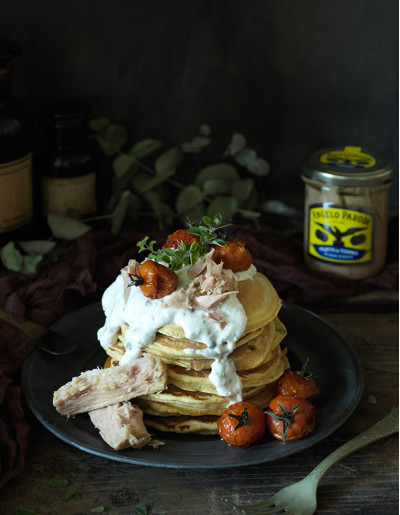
<box><xmin>0</xmin><ymin>307</ymin><xmax>399</xmax><ymax>515</ymax></box>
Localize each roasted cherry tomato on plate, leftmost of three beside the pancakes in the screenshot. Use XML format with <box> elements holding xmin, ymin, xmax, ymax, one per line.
<box><xmin>217</xmin><ymin>402</ymin><xmax>267</xmax><ymax>447</ymax></box>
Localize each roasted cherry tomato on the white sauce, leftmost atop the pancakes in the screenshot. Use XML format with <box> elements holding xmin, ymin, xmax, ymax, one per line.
<box><xmin>129</xmin><ymin>259</ymin><xmax>178</xmax><ymax>299</ymax></box>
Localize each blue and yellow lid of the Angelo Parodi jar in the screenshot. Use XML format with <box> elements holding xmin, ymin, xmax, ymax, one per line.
<box><xmin>303</xmin><ymin>146</ymin><xmax>393</xmax><ymax>186</ymax></box>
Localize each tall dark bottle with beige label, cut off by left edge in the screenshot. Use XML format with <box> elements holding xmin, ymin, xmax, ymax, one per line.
<box><xmin>0</xmin><ymin>39</ymin><xmax>33</xmax><ymax>237</ymax></box>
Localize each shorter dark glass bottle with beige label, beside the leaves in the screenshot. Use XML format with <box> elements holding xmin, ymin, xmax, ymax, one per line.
<box><xmin>41</xmin><ymin>100</ymin><xmax>97</xmax><ymax>215</ymax></box>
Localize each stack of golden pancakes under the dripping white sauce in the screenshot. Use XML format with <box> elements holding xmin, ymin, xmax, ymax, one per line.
<box><xmin>106</xmin><ymin>273</ymin><xmax>289</xmax><ymax>435</ymax></box>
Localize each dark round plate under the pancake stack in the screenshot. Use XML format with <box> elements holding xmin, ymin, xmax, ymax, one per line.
<box><xmin>22</xmin><ymin>303</ymin><xmax>363</xmax><ymax>468</ymax></box>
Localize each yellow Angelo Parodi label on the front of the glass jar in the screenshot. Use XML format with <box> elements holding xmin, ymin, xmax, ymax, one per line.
<box><xmin>308</xmin><ymin>202</ymin><xmax>375</xmax><ymax>265</ymax></box>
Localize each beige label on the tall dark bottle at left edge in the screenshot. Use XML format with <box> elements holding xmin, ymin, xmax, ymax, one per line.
<box><xmin>0</xmin><ymin>154</ymin><xmax>32</xmax><ymax>232</ymax></box>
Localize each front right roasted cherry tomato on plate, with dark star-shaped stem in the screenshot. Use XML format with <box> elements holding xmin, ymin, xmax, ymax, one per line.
<box><xmin>266</xmin><ymin>395</ymin><xmax>316</xmax><ymax>442</ymax></box>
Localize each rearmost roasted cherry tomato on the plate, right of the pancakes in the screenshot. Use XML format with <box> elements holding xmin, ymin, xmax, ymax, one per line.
<box><xmin>275</xmin><ymin>359</ymin><xmax>319</xmax><ymax>401</ymax></box>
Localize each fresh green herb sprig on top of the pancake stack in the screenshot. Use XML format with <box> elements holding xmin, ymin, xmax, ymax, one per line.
<box><xmin>137</xmin><ymin>213</ymin><xmax>232</xmax><ymax>271</ymax></box>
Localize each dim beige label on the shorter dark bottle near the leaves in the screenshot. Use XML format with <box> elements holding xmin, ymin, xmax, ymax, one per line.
<box><xmin>42</xmin><ymin>173</ymin><xmax>97</xmax><ymax>215</ymax></box>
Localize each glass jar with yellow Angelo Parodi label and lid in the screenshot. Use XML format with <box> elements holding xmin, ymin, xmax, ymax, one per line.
<box><xmin>302</xmin><ymin>146</ymin><xmax>393</xmax><ymax>279</ymax></box>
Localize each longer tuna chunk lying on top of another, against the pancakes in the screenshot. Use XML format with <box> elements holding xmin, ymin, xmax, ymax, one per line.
<box><xmin>53</xmin><ymin>354</ymin><xmax>167</xmax><ymax>417</ymax></box>
